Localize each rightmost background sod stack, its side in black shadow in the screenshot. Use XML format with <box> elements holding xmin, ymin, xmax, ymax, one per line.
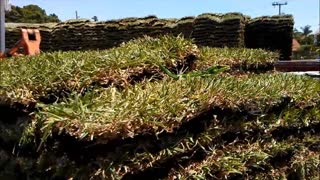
<box><xmin>245</xmin><ymin>15</ymin><xmax>294</xmax><ymax>60</ymax></box>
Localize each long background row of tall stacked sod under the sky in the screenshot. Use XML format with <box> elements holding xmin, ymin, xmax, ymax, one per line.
<box><xmin>6</xmin><ymin>13</ymin><xmax>294</xmax><ymax>59</ymax></box>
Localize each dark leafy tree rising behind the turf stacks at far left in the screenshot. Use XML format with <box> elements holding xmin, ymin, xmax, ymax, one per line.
<box><xmin>6</xmin><ymin>4</ymin><xmax>60</xmax><ymax>23</ymax></box>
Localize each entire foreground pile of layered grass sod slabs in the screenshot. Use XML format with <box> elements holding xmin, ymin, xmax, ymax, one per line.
<box><xmin>0</xmin><ymin>35</ymin><xmax>320</xmax><ymax>180</ymax></box>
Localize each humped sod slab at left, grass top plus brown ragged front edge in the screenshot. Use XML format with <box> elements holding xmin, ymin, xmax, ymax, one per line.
<box><xmin>0</xmin><ymin>36</ymin><xmax>198</xmax><ymax>109</ymax></box>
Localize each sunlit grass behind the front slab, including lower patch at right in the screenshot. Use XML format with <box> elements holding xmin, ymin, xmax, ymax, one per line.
<box><xmin>0</xmin><ymin>35</ymin><xmax>278</xmax><ymax>106</ymax></box>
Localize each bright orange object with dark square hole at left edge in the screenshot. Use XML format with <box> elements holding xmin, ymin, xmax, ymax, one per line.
<box><xmin>0</xmin><ymin>29</ymin><xmax>41</xmax><ymax>58</ymax></box>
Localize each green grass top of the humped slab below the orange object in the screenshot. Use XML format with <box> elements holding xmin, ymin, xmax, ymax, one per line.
<box><xmin>0</xmin><ymin>36</ymin><xmax>197</xmax><ymax>103</ymax></box>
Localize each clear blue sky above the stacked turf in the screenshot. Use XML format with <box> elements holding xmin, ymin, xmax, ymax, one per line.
<box><xmin>10</xmin><ymin>0</ymin><xmax>320</xmax><ymax>30</ymax></box>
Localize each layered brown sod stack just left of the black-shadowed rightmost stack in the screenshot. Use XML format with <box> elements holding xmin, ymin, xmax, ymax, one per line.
<box><xmin>192</xmin><ymin>13</ymin><xmax>247</xmax><ymax>47</ymax></box>
